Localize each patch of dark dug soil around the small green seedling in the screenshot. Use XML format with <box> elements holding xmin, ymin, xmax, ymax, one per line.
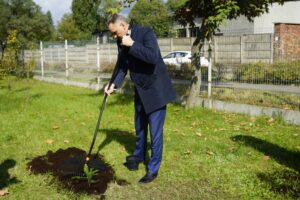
<box><xmin>27</xmin><ymin>147</ymin><xmax>128</xmax><ymax>195</ymax></box>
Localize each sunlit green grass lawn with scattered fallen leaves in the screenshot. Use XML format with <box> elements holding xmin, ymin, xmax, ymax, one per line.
<box><xmin>0</xmin><ymin>77</ymin><xmax>300</xmax><ymax>200</ymax></box>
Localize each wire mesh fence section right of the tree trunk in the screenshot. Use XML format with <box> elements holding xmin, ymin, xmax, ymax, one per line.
<box><xmin>200</xmin><ymin>32</ymin><xmax>300</xmax><ymax>111</ymax></box>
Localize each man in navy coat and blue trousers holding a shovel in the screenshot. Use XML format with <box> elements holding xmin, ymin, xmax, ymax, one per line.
<box><xmin>105</xmin><ymin>15</ymin><xmax>176</xmax><ymax>183</ymax></box>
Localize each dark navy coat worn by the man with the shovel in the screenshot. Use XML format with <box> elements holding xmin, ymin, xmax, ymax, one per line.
<box><xmin>114</xmin><ymin>25</ymin><xmax>176</xmax><ymax>114</ymax></box>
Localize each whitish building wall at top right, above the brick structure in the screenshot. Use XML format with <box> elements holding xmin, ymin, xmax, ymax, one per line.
<box><xmin>254</xmin><ymin>1</ymin><xmax>300</xmax><ymax>33</ymax></box>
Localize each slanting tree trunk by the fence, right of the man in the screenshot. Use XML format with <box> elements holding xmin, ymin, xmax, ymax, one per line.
<box><xmin>185</xmin><ymin>31</ymin><xmax>205</xmax><ymax>108</ymax></box>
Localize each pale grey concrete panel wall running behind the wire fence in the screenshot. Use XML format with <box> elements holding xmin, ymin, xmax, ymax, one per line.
<box><xmin>24</xmin><ymin>34</ymin><xmax>282</xmax><ymax>68</ymax></box>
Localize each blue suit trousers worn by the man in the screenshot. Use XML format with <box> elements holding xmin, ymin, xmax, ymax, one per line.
<box><xmin>133</xmin><ymin>94</ymin><xmax>166</xmax><ymax>173</ymax></box>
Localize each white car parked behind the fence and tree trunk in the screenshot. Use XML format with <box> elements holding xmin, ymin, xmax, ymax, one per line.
<box><xmin>163</xmin><ymin>51</ymin><xmax>208</xmax><ymax>69</ymax></box>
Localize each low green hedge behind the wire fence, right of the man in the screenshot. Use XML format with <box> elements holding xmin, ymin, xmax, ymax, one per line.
<box><xmin>167</xmin><ymin>60</ymin><xmax>300</xmax><ymax>85</ymax></box>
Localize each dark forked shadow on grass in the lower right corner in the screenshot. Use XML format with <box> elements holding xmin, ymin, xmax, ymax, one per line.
<box><xmin>231</xmin><ymin>135</ymin><xmax>300</xmax><ymax>199</ymax></box>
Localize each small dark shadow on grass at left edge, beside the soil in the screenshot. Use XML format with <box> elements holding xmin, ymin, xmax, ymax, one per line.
<box><xmin>0</xmin><ymin>159</ymin><xmax>20</xmax><ymax>190</ymax></box>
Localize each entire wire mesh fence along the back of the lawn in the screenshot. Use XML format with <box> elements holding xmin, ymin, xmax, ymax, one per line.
<box><xmin>24</xmin><ymin>30</ymin><xmax>300</xmax><ymax>111</ymax></box>
